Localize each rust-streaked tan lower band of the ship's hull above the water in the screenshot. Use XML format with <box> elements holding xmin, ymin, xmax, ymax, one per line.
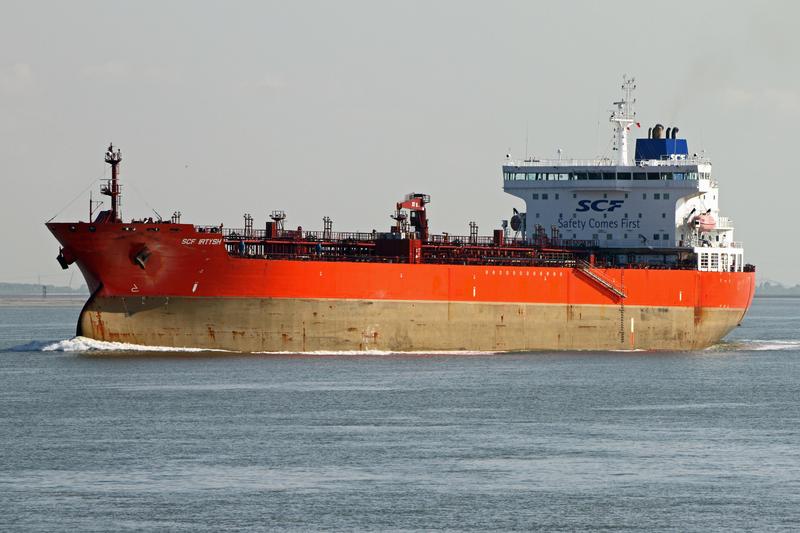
<box><xmin>78</xmin><ymin>296</ymin><xmax>746</xmax><ymax>352</ymax></box>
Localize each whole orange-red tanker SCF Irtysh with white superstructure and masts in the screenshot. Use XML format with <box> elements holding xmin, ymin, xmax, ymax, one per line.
<box><xmin>47</xmin><ymin>79</ymin><xmax>755</xmax><ymax>352</ymax></box>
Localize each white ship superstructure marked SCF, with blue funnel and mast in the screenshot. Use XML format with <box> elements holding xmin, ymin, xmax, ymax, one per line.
<box><xmin>503</xmin><ymin>79</ymin><xmax>744</xmax><ymax>271</ymax></box>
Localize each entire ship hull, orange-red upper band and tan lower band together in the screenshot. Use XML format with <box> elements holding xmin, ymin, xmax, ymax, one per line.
<box><xmin>49</xmin><ymin>223</ymin><xmax>755</xmax><ymax>352</ymax></box>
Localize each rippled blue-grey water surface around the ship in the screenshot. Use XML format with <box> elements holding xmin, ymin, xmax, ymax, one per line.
<box><xmin>0</xmin><ymin>299</ymin><xmax>800</xmax><ymax>531</ymax></box>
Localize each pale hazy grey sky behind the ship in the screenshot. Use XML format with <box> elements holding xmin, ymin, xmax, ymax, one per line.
<box><xmin>0</xmin><ymin>0</ymin><xmax>800</xmax><ymax>286</ymax></box>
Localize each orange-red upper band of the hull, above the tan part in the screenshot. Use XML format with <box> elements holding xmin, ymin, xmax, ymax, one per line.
<box><xmin>48</xmin><ymin>223</ymin><xmax>755</xmax><ymax>311</ymax></box>
